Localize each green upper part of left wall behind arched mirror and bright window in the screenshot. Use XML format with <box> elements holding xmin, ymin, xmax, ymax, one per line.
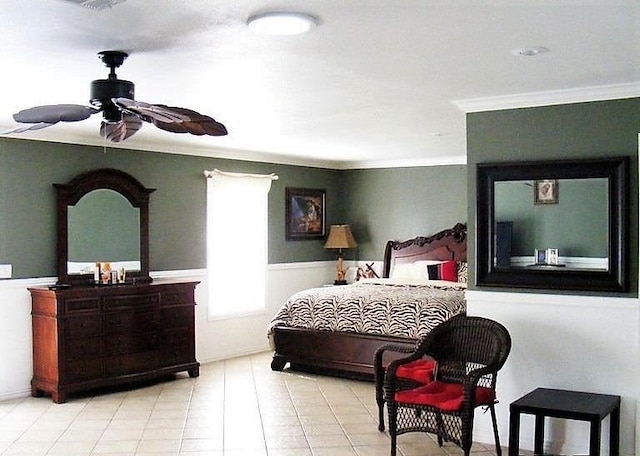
<box><xmin>0</xmin><ymin>138</ymin><xmax>344</xmax><ymax>278</ymax></box>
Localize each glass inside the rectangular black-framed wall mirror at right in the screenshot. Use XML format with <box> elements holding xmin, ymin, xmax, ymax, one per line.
<box><xmin>493</xmin><ymin>178</ymin><xmax>609</xmax><ymax>271</ymax></box>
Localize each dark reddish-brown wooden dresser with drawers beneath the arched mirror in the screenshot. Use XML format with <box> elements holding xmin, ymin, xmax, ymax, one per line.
<box><xmin>29</xmin><ymin>281</ymin><xmax>200</xmax><ymax>403</ymax></box>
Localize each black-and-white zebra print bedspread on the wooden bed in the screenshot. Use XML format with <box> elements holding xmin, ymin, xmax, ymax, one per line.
<box><xmin>268</xmin><ymin>282</ymin><xmax>466</xmax><ymax>339</ymax></box>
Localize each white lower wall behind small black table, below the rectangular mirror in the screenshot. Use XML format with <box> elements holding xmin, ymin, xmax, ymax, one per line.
<box><xmin>467</xmin><ymin>290</ymin><xmax>640</xmax><ymax>456</ymax></box>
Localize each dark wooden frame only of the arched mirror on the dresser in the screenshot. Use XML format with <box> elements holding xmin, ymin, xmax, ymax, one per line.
<box><xmin>53</xmin><ymin>168</ymin><xmax>155</xmax><ymax>285</ymax></box>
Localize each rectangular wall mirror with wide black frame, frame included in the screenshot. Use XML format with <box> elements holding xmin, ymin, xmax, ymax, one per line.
<box><xmin>476</xmin><ymin>158</ymin><xmax>628</xmax><ymax>292</ymax></box>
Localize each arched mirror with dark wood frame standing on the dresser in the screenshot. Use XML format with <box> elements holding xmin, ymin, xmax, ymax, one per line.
<box><xmin>54</xmin><ymin>169</ymin><xmax>154</xmax><ymax>285</ymax></box>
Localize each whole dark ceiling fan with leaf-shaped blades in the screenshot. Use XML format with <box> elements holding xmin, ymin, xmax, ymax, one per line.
<box><xmin>7</xmin><ymin>51</ymin><xmax>227</xmax><ymax>142</ymax></box>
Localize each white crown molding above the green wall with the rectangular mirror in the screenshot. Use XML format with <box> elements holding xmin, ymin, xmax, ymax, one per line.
<box><xmin>453</xmin><ymin>82</ymin><xmax>640</xmax><ymax>114</ymax></box>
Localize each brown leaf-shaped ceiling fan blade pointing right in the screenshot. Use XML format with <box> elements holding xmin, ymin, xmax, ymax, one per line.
<box><xmin>112</xmin><ymin>98</ymin><xmax>228</xmax><ymax>136</ymax></box>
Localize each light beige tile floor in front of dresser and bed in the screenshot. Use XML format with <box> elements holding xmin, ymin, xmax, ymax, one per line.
<box><xmin>0</xmin><ymin>353</ymin><xmax>504</xmax><ymax>456</ymax></box>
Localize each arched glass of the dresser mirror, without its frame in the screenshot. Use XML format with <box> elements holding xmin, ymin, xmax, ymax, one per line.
<box><xmin>67</xmin><ymin>189</ymin><xmax>140</xmax><ymax>274</ymax></box>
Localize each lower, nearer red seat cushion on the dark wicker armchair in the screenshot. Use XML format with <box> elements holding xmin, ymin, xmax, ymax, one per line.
<box><xmin>395</xmin><ymin>381</ymin><xmax>496</xmax><ymax>412</ymax></box>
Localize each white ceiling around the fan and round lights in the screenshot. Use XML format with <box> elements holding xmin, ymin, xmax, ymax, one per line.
<box><xmin>0</xmin><ymin>0</ymin><xmax>640</xmax><ymax>168</ymax></box>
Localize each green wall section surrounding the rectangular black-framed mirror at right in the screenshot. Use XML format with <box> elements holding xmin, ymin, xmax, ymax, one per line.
<box><xmin>467</xmin><ymin>98</ymin><xmax>640</xmax><ymax>296</ymax></box>
